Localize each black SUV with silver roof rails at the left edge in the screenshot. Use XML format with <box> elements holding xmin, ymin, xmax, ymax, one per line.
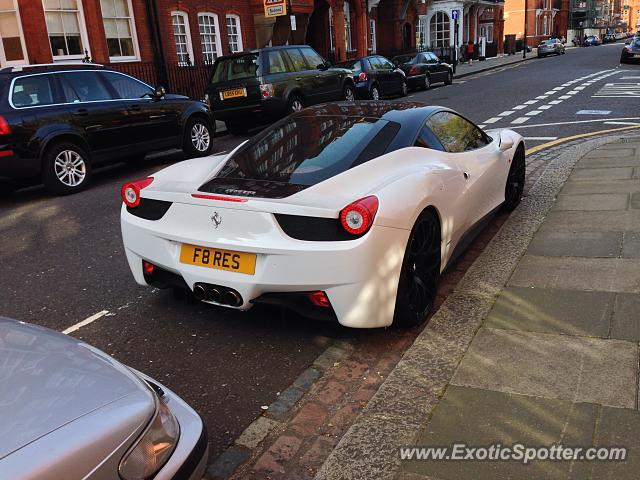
<box><xmin>0</xmin><ymin>64</ymin><xmax>215</xmax><ymax>194</ymax></box>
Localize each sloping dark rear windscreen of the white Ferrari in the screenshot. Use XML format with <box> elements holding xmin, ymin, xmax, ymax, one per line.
<box><xmin>212</xmin><ymin>116</ymin><xmax>400</xmax><ymax>186</ymax></box>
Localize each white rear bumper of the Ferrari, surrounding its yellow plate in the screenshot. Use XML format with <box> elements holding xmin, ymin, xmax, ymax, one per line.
<box><xmin>121</xmin><ymin>204</ymin><xmax>409</xmax><ymax>328</ymax></box>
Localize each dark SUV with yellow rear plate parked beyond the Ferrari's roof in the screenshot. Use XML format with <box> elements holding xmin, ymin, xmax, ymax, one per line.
<box><xmin>206</xmin><ymin>45</ymin><xmax>354</xmax><ymax>133</ymax></box>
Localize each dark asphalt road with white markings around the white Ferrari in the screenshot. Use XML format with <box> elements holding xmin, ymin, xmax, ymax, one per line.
<box><xmin>0</xmin><ymin>44</ymin><xmax>640</xmax><ymax>457</ymax></box>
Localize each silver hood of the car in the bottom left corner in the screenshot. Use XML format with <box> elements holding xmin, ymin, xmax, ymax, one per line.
<box><xmin>0</xmin><ymin>317</ymin><xmax>153</xmax><ymax>459</ymax></box>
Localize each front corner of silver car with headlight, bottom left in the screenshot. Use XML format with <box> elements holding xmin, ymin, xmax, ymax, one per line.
<box><xmin>0</xmin><ymin>317</ymin><xmax>208</xmax><ymax>480</ymax></box>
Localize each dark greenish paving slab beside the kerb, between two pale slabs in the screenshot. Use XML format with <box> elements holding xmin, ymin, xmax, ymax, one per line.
<box><xmin>485</xmin><ymin>287</ymin><xmax>626</xmax><ymax>338</ymax></box>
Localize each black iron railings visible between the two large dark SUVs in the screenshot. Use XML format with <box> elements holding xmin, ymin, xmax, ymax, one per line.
<box><xmin>108</xmin><ymin>62</ymin><xmax>213</xmax><ymax>100</ymax></box>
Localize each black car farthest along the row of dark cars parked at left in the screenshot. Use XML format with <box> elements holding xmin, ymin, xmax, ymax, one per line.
<box><xmin>393</xmin><ymin>52</ymin><xmax>453</xmax><ymax>90</ymax></box>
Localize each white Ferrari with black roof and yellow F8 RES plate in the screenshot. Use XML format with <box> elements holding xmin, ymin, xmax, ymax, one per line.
<box><xmin>121</xmin><ymin>102</ymin><xmax>525</xmax><ymax>328</ymax></box>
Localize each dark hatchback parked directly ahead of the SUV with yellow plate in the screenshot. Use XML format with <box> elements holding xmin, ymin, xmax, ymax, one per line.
<box><xmin>336</xmin><ymin>55</ymin><xmax>408</xmax><ymax>100</ymax></box>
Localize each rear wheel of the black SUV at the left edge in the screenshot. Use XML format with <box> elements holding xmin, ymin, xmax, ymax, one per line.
<box><xmin>42</xmin><ymin>142</ymin><xmax>91</xmax><ymax>195</ymax></box>
